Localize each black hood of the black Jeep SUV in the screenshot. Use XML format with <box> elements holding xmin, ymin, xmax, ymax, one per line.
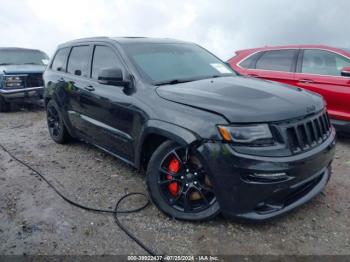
<box><xmin>156</xmin><ymin>77</ymin><xmax>324</xmax><ymax>123</ymax></box>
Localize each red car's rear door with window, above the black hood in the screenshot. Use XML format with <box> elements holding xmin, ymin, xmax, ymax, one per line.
<box><xmin>245</xmin><ymin>49</ymin><xmax>299</xmax><ymax>85</ymax></box>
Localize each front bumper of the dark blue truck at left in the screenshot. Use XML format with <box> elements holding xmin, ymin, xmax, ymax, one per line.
<box><xmin>0</xmin><ymin>86</ymin><xmax>44</xmax><ymax>102</ymax></box>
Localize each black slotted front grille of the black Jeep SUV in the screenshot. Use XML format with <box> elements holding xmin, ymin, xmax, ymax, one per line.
<box><xmin>285</xmin><ymin>111</ymin><xmax>331</xmax><ymax>154</ymax></box>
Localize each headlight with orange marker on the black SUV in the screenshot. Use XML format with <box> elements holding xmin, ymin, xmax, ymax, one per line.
<box><xmin>218</xmin><ymin>124</ymin><xmax>273</xmax><ymax>144</ymax></box>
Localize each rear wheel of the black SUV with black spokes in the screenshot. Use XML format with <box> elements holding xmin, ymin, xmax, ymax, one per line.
<box><xmin>46</xmin><ymin>100</ymin><xmax>71</xmax><ymax>144</ymax></box>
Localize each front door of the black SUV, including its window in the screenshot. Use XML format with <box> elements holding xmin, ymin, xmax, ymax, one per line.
<box><xmin>80</xmin><ymin>45</ymin><xmax>136</xmax><ymax>160</ymax></box>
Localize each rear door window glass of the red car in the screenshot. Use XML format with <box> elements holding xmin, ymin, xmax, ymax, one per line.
<box><xmin>256</xmin><ymin>50</ymin><xmax>296</xmax><ymax>72</ymax></box>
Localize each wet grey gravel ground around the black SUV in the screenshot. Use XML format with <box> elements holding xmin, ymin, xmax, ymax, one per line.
<box><xmin>0</xmin><ymin>106</ymin><xmax>350</xmax><ymax>255</ymax></box>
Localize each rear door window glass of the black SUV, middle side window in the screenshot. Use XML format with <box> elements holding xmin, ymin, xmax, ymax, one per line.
<box><xmin>67</xmin><ymin>46</ymin><xmax>90</xmax><ymax>77</ymax></box>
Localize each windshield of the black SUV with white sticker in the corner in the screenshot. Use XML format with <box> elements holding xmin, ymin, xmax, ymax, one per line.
<box><xmin>124</xmin><ymin>43</ymin><xmax>236</xmax><ymax>85</ymax></box>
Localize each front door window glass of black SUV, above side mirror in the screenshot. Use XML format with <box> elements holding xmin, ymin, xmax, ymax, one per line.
<box><xmin>92</xmin><ymin>46</ymin><xmax>123</xmax><ymax>79</ymax></box>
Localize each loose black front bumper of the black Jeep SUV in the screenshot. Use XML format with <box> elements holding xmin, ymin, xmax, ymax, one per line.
<box><xmin>198</xmin><ymin>128</ymin><xmax>335</xmax><ymax>221</ymax></box>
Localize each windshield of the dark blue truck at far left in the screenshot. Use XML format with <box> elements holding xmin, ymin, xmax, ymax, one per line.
<box><xmin>0</xmin><ymin>49</ymin><xmax>49</xmax><ymax>65</ymax></box>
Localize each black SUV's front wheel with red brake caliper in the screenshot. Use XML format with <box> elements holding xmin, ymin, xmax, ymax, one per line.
<box><xmin>146</xmin><ymin>141</ymin><xmax>220</xmax><ymax>221</ymax></box>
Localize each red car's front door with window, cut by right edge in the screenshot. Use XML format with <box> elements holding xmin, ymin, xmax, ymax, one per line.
<box><xmin>295</xmin><ymin>49</ymin><xmax>350</xmax><ymax>121</ymax></box>
